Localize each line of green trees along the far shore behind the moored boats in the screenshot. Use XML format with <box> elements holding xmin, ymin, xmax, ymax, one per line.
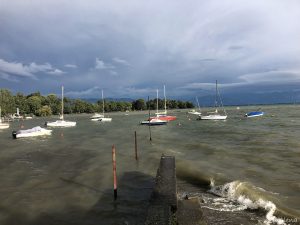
<box><xmin>0</xmin><ymin>89</ymin><xmax>194</xmax><ymax>116</ymax></box>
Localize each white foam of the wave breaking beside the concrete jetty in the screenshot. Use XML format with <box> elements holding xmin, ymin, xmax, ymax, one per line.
<box><xmin>205</xmin><ymin>181</ymin><xmax>287</xmax><ymax>225</ymax></box>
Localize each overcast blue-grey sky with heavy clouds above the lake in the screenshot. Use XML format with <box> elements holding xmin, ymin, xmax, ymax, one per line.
<box><xmin>0</xmin><ymin>0</ymin><xmax>300</xmax><ymax>98</ymax></box>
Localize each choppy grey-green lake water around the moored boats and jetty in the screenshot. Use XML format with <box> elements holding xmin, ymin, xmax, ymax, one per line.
<box><xmin>0</xmin><ymin>105</ymin><xmax>300</xmax><ymax>225</ymax></box>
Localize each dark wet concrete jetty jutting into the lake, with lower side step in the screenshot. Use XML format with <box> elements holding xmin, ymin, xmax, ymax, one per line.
<box><xmin>145</xmin><ymin>155</ymin><xmax>206</xmax><ymax>225</ymax></box>
